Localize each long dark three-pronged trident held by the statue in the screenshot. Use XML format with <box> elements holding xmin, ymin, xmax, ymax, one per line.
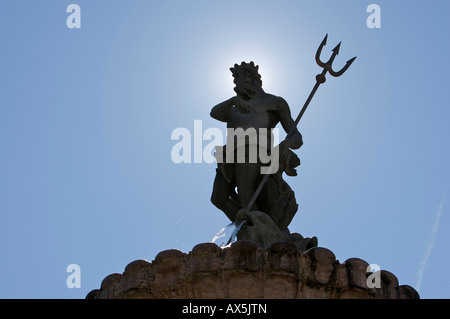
<box><xmin>247</xmin><ymin>33</ymin><xmax>356</xmax><ymax>211</ymax></box>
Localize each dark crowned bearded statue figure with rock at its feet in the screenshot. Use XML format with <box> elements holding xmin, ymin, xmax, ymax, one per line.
<box><xmin>211</xmin><ymin>62</ymin><xmax>317</xmax><ymax>249</ymax></box>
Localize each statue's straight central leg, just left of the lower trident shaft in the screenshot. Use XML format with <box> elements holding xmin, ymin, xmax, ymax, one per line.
<box><xmin>235</xmin><ymin>163</ymin><xmax>261</xmax><ymax>211</ymax></box>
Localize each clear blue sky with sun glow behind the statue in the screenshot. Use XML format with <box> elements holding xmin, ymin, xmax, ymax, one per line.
<box><xmin>0</xmin><ymin>0</ymin><xmax>450</xmax><ymax>298</ymax></box>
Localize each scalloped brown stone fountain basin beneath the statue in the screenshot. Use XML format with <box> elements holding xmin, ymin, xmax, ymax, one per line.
<box><xmin>86</xmin><ymin>241</ymin><xmax>419</xmax><ymax>299</ymax></box>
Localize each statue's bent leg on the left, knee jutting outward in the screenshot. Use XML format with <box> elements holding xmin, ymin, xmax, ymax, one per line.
<box><xmin>211</xmin><ymin>172</ymin><xmax>241</xmax><ymax>222</ymax></box>
